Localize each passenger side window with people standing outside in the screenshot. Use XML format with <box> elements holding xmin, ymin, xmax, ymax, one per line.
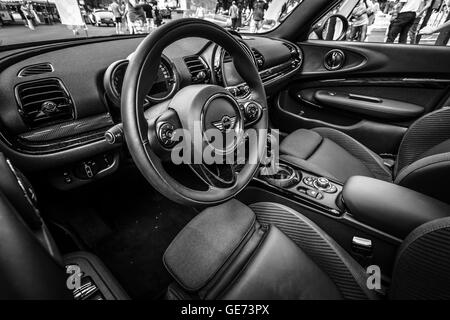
<box><xmin>309</xmin><ymin>0</ymin><xmax>450</xmax><ymax>46</ymax></box>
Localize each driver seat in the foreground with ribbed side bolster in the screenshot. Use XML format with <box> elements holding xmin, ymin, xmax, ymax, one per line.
<box><xmin>163</xmin><ymin>200</ymin><xmax>450</xmax><ymax>300</ymax></box>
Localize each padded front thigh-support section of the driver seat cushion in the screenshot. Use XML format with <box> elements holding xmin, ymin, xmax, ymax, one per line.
<box><xmin>163</xmin><ymin>200</ymin><xmax>256</xmax><ymax>291</ymax></box>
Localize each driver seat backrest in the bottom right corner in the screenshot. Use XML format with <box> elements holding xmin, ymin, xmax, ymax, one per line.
<box><xmin>389</xmin><ymin>217</ymin><xmax>450</xmax><ymax>300</ymax></box>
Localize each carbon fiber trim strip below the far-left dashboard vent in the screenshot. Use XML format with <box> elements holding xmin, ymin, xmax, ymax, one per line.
<box><xmin>19</xmin><ymin>113</ymin><xmax>114</xmax><ymax>144</ymax></box>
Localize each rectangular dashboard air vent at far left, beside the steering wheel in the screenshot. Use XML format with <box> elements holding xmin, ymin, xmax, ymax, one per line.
<box><xmin>16</xmin><ymin>79</ymin><xmax>73</xmax><ymax>128</ymax></box>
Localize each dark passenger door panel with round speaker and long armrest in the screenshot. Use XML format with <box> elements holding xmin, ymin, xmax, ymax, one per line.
<box><xmin>272</xmin><ymin>41</ymin><xmax>450</xmax><ymax>154</ymax></box>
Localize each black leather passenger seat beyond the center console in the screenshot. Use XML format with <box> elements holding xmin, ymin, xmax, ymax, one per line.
<box><xmin>280</xmin><ymin>107</ymin><xmax>450</xmax><ymax>202</ymax></box>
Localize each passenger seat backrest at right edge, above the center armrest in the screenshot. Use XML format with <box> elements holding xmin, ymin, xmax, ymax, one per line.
<box><xmin>394</xmin><ymin>107</ymin><xmax>450</xmax><ymax>202</ymax></box>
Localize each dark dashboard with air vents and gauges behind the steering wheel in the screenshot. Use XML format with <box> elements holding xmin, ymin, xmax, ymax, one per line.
<box><xmin>0</xmin><ymin>36</ymin><xmax>303</xmax><ymax>186</ymax></box>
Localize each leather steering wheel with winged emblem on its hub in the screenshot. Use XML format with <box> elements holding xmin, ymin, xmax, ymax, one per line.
<box><xmin>121</xmin><ymin>18</ymin><xmax>268</xmax><ymax>205</ymax></box>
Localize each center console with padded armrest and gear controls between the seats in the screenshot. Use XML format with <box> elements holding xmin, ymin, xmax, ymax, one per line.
<box><xmin>239</xmin><ymin>149</ymin><xmax>450</xmax><ymax>277</ymax></box>
